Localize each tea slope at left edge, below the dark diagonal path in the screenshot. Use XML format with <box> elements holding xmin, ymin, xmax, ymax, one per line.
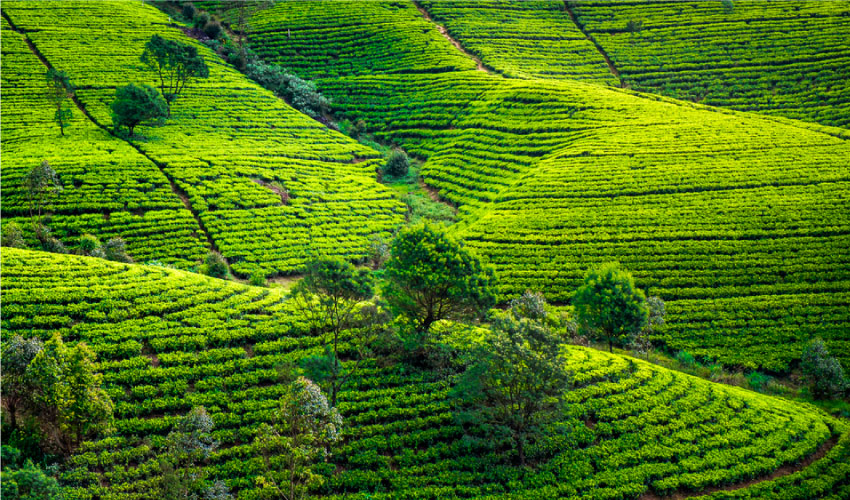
<box><xmin>0</xmin><ymin>19</ymin><xmax>206</xmax><ymax>267</ymax></box>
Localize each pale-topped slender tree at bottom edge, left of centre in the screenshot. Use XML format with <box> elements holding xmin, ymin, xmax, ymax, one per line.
<box><xmin>254</xmin><ymin>377</ymin><xmax>342</xmax><ymax>500</ymax></box>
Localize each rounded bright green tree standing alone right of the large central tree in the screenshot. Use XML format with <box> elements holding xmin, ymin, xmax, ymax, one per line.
<box><xmin>573</xmin><ymin>263</ymin><xmax>649</xmax><ymax>352</ymax></box>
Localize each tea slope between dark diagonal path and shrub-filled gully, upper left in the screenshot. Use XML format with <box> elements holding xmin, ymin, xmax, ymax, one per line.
<box><xmin>3</xmin><ymin>1</ymin><xmax>404</xmax><ymax>274</ymax></box>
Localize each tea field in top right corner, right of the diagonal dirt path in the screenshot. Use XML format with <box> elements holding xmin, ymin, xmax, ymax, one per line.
<box><xmin>570</xmin><ymin>0</ymin><xmax>850</xmax><ymax>128</ymax></box>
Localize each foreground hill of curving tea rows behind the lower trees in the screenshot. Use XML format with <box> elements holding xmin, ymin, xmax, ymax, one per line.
<box><xmin>2</xmin><ymin>249</ymin><xmax>850</xmax><ymax>499</ymax></box>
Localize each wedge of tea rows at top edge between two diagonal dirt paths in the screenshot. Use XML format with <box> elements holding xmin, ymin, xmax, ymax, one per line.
<box><xmin>421</xmin><ymin>0</ymin><xmax>620</xmax><ymax>86</ymax></box>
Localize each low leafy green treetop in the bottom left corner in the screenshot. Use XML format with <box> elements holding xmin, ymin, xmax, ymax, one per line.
<box><xmin>0</xmin><ymin>445</ymin><xmax>64</xmax><ymax>500</ymax></box>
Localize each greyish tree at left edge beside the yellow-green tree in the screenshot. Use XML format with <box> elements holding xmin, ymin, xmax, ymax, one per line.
<box><xmin>0</xmin><ymin>335</ymin><xmax>43</xmax><ymax>433</ymax></box>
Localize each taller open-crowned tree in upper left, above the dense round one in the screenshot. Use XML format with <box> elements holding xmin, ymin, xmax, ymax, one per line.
<box><xmin>140</xmin><ymin>35</ymin><xmax>210</xmax><ymax>114</ymax></box>
